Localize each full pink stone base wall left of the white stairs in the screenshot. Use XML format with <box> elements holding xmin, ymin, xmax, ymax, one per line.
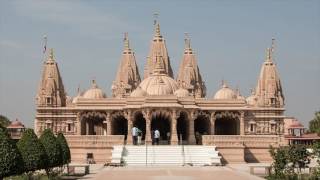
<box><xmin>65</xmin><ymin>135</ymin><xmax>124</xmax><ymax>164</ymax></box>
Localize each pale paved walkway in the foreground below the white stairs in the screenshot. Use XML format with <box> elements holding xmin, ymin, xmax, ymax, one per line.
<box><xmin>83</xmin><ymin>166</ymin><xmax>262</xmax><ymax>180</ymax></box>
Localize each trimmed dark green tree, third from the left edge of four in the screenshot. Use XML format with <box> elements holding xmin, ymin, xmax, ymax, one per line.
<box><xmin>40</xmin><ymin>129</ymin><xmax>62</xmax><ymax>178</ymax></box>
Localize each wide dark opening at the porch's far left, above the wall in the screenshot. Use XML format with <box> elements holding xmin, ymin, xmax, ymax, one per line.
<box><xmin>81</xmin><ymin>116</ymin><xmax>105</xmax><ymax>135</ymax></box>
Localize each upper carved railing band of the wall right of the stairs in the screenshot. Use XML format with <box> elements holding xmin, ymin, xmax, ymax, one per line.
<box><xmin>202</xmin><ymin>135</ymin><xmax>284</xmax><ymax>148</ymax></box>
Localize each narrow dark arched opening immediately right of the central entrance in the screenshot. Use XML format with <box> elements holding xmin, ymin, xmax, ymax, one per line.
<box><xmin>177</xmin><ymin>112</ymin><xmax>188</xmax><ymax>144</ymax></box>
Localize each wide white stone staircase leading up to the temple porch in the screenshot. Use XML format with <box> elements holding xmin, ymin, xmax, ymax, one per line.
<box><xmin>112</xmin><ymin>145</ymin><xmax>221</xmax><ymax>166</ymax></box>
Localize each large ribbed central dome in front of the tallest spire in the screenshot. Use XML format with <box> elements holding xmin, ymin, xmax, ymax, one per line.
<box><xmin>139</xmin><ymin>74</ymin><xmax>178</xmax><ymax>95</ymax></box>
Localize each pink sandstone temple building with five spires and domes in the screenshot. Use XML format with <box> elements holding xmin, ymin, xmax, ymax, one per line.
<box><xmin>34</xmin><ymin>22</ymin><xmax>285</xmax><ymax>162</ymax></box>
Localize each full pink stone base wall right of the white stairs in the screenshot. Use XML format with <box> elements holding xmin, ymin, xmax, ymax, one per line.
<box><xmin>202</xmin><ymin>135</ymin><xmax>285</xmax><ymax>163</ymax></box>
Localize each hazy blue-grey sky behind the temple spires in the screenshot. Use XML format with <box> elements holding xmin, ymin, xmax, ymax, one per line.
<box><xmin>0</xmin><ymin>0</ymin><xmax>320</xmax><ymax>127</ymax></box>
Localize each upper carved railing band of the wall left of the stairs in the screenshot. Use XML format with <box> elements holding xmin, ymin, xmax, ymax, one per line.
<box><xmin>65</xmin><ymin>135</ymin><xmax>124</xmax><ymax>148</ymax></box>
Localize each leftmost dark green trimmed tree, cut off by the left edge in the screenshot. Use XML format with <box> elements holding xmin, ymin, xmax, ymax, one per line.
<box><xmin>0</xmin><ymin>128</ymin><xmax>23</xmax><ymax>179</ymax></box>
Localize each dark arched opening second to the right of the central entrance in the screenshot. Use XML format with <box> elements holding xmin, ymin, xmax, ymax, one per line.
<box><xmin>194</xmin><ymin>115</ymin><xmax>210</xmax><ymax>144</ymax></box>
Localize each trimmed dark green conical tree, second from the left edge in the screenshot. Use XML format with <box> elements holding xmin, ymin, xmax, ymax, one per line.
<box><xmin>17</xmin><ymin>129</ymin><xmax>48</xmax><ymax>174</ymax></box>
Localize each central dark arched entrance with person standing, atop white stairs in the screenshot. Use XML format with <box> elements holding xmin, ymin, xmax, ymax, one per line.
<box><xmin>151</xmin><ymin>112</ymin><xmax>171</xmax><ymax>144</ymax></box>
